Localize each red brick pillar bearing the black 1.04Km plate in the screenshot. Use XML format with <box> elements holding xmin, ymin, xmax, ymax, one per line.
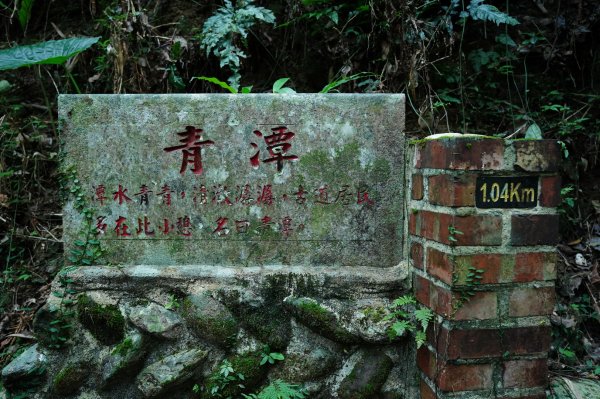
<box><xmin>408</xmin><ymin>136</ymin><xmax>560</xmax><ymax>399</ymax></box>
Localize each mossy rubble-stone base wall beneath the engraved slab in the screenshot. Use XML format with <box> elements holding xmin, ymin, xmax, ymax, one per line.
<box><xmin>3</xmin><ymin>265</ymin><xmax>418</xmax><ymax>399</ymax></box>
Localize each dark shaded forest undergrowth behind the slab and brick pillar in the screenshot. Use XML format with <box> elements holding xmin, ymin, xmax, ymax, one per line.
<box><xmin>0</xmin><ymin>0</ymin><xmax>600</xmax><ymax>384</ymax></box>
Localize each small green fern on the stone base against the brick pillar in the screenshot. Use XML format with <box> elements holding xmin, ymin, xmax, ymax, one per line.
<box><xmin>385</xmin><ymin>295</ymin><xmax>433</xmax><ymax>348</ymax></box>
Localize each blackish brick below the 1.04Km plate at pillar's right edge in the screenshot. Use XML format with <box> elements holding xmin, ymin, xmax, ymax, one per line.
<box><xmin>510</xmin><ymin>215</ymin><xmax>558</xmax><ymax>246</ymax></box>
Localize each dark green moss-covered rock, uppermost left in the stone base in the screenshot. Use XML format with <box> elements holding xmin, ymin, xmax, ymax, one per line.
<box><xmin>77</xmin><ymin>295</ymin><xmax>125</xmax><ymax>345</ymax></box>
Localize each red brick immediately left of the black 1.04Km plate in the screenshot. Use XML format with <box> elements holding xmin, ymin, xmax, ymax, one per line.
<box><xmin>429</xmin><ymin>174</ymin><xmax>476</xmax><ymax>206</ymax></box>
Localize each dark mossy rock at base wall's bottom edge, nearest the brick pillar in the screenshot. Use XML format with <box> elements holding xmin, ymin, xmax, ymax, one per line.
<box><xmin>338</xmin><ymin>349</ymin><xmax>394</xmax><ymax>399</ymax></box>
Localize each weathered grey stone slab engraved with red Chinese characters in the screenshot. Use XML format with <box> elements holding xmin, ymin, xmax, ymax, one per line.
<box><xmin>59</xmin><ymin>94</ymin><xmax>405</xmax><ymax>267</ymax></box>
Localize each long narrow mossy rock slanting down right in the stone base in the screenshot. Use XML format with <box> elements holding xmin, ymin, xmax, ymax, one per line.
<box><xmin>284</xmin><ymin>297</ymin><xmax>360</xmax><ymax>344</ymax></box>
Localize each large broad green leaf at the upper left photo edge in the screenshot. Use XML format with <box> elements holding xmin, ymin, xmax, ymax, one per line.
<box><xmin>0</xmin><ymin>37</ymin><xmax>100</xmax><ymax>71</ymax></box>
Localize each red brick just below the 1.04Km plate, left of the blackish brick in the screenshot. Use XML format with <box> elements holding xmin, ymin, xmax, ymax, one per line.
<box><xmin>453</xmin><ymin>215</ymin><xmax>502</xmax><ymax>245</ymax></box>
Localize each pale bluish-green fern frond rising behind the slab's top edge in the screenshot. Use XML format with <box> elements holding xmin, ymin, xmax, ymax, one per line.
<box><xmin>201</xmin><ymin>0</ymin><xmax>275</xmax><ymax>90</ymax></box>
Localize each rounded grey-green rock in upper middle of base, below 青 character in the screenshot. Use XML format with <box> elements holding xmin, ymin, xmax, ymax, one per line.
<box><xmin>181</xmin><ymin>294</ymin><xmax>239</xmax><ymax>347</ymax></box>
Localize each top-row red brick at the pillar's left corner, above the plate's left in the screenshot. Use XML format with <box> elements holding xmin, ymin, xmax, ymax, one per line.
<box><xmin>415</xmin><ymin>137</ymin><xmax>504</xmax><ymax>170</ymax></box>
